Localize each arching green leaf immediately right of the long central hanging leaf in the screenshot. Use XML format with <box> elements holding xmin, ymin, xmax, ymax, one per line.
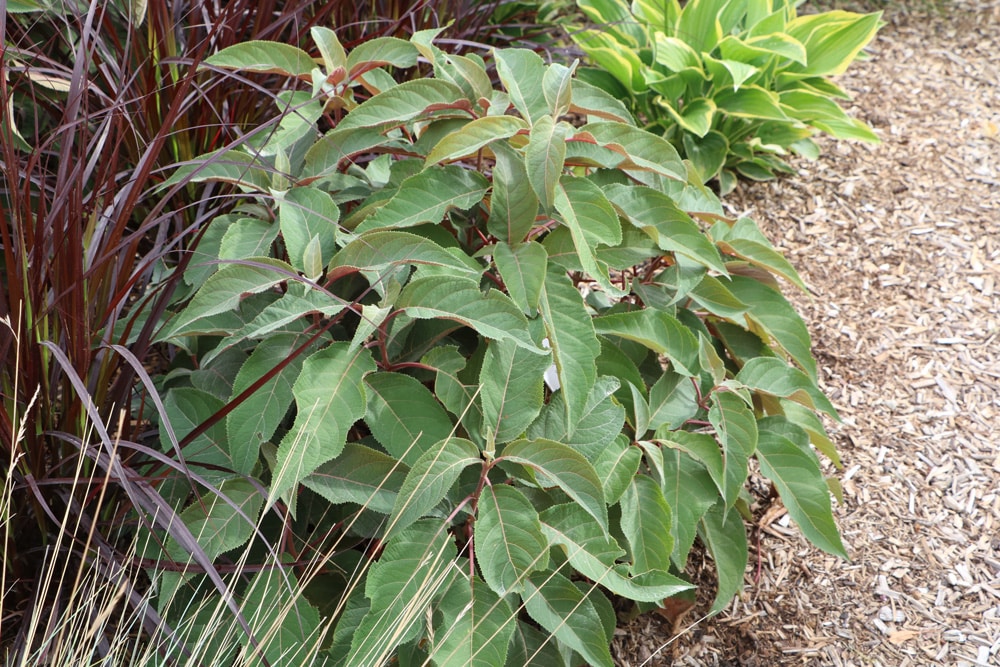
<box><xmin>594</xmin><ymin>308</ymin><xmax>699</xmax><ymax>376</ymax></box>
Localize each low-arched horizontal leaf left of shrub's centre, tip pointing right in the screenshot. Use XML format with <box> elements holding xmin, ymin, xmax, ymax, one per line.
<box><xmin>330</xmin><ymin>230</ymin><xmax>482</xmax><ymax>277</ymax></box>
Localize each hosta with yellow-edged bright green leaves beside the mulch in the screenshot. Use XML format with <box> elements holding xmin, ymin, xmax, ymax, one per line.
<box><xmin>571</xmin><ymin>0</ymin><xmax>881</xmax><ymax>192</ymax></box>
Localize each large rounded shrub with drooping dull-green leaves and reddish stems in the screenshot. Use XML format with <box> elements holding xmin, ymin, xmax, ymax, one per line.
<box><xmin>150</xmin><ymin>29</ymin><xmax>844</xmax><ymax>666</ymax></box>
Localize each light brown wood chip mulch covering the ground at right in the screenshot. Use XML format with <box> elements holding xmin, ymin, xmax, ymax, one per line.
<box><xmin>614</xmin><ymin>1</ymin><xmax>1000</xmax><ymax>667</ymax></box>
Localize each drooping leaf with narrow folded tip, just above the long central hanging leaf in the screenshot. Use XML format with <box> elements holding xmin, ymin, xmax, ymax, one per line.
<box><xmin>554</xmin><ymin>176</ymin><xmax>625</xmax><ymax>296</ymax></box>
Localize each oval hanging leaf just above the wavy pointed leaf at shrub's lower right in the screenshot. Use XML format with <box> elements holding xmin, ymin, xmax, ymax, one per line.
<box><xmin>620</xmin><ymin>475</ymin><xmax>681</xmax><ymax>576</ymax></box>
